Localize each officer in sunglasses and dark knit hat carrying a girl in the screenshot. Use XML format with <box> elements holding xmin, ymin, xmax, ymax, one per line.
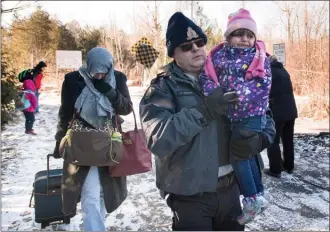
<box><xmin>140</xmin><ymin>12</ymin><xmax>275</xmax><ymax>231</ymax></box>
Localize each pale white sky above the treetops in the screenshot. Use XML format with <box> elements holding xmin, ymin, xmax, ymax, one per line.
<box><xmin>2</xmin><ymin>1</ymin><xmax>283</xmax><ymax>37</ymax></box>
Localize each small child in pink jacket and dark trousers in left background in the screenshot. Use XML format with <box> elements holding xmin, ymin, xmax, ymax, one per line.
<box><xmin>23</xmin><ymin>80</ymin><xmax>37</xmax><ymax>135</ymax></box>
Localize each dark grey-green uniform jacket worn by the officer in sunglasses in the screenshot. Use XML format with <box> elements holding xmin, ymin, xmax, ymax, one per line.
<box><xmin>140</xmin><ymin>62</ymin><xmax>275</xmax><ymax>197</ymax></box>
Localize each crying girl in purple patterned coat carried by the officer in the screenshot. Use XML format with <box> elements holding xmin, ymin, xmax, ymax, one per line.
<box><xmin>199</xmin><ymin>9</ymin><xmax>271</xmax><ymax>224</ymax></box>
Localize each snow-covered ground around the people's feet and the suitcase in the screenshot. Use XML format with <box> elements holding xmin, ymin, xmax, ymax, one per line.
<box><xmin>1</xmin><ymin>87</ymin><xmax>329</xmax><ymax>231</ymax></box>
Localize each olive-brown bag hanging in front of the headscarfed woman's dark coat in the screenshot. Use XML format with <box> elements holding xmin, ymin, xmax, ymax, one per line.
<box><xmin>59</xmin><ymin>112</ymin><xmax>123</xmax><ymax>166</ymax></box>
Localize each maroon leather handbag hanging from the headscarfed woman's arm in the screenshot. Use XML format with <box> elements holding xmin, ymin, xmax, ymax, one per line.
<box><xmin>109</xmin><ymin>106</ymin><xmax>152</xmax><ymax>177</ymax></box>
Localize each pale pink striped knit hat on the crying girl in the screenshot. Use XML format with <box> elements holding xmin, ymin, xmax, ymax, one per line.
<box><xmin>225</xmin><ymin>8</ymin><xmax>257</xmax><ymax>38</ymax></box>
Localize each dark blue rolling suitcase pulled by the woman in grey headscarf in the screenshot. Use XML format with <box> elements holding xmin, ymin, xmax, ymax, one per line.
<box><xmin>30</xmin><ymin>154</ymin><xmax>76</xmax><ymax>229</ymax></box>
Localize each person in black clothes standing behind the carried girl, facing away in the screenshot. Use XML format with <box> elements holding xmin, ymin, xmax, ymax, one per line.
<box><xmin>264</xmin><ymin>56</ymin><xmax>298</xmax><ymax>178</ymax></box>
